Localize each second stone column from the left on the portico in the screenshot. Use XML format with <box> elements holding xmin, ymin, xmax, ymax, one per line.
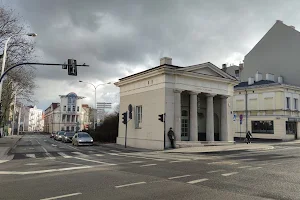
<box><xmin>190</xmin><ymin>92</ymin><xmax>198</xmax><ymax>141</ymax></box>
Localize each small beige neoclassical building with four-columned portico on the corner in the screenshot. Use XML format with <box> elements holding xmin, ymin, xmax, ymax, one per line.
<box><xmin>115</xmin><ymin>58</ymin><xmax>238</xmax><ymax>149</ymax></box>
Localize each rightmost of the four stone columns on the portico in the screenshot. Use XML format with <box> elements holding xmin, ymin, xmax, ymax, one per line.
<box><xmin>220</xmin><ymin>96</ymin><xmax>228</xmax><ymax>141</ymax></box>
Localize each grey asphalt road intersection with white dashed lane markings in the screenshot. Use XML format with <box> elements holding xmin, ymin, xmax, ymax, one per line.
<box><xmin>0</xmin><ymin>135</ymin><xmax>300</xmax><ymax>200</ymax></box>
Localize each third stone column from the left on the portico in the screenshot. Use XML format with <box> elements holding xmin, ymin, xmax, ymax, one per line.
<box><xmin>206</xmin><ymin>94</ymin><xmax>215</xmax><ymax>141</ymax></box>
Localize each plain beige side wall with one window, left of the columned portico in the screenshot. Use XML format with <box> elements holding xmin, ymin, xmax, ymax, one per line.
<box><xmin>117</xmin><ymin>75</ymin><xmax>165</xmax><ymax>149</ymax></box>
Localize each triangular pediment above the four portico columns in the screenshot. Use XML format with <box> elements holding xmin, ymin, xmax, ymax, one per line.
<box><xmin>178</xmin><ymin>62</ymin><xmax>236</xmax><ymax>80</ymax></box>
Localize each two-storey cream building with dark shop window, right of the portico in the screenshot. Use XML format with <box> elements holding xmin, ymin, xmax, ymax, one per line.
<box><xmin>232</xmin><ymin>72</ymin><xmax>300</xmax><ymax>140</ymax></box>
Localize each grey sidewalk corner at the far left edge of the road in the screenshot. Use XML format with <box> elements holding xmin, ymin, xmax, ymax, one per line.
<box><xmin>0</xmin><ymin>135</ymin><xmax>23</xmax><ymax>163</ymax></box>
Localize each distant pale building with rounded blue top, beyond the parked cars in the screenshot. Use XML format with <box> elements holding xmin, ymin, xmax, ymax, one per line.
<box><xmin>44</xmin><ymin>92</ymin><xmax>90</xmax><ymax>133</ymax></box>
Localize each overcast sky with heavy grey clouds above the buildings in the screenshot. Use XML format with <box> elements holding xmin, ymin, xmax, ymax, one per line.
<box><xmin>0</xmin><ymin>0</ymin><xmax>300</xmax><ymax>109</ymax></box>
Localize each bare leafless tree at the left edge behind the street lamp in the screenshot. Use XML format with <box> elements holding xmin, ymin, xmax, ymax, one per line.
<box><xmin>0</xmin><ymin>7</ymin><xmax>36</xmax><ymax>126</ymax></box>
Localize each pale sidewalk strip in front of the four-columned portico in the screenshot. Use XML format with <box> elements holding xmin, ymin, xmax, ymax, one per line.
<box><xmin>165</xmin><ymin>143</ymin><xmax>274</xmax><ymax>153</ymax></box>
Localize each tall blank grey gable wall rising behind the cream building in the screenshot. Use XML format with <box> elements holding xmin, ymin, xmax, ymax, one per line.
<box><xmin>242</xmin><ymin>22</ymin><xmax>300</xmax><ymax>85</ymax></box>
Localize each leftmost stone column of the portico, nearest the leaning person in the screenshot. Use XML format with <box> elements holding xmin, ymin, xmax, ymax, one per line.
<box><xmin>174</xmin><ymin>89</ymin><xmax>182</xmax><ymax>141</ymax></box>
